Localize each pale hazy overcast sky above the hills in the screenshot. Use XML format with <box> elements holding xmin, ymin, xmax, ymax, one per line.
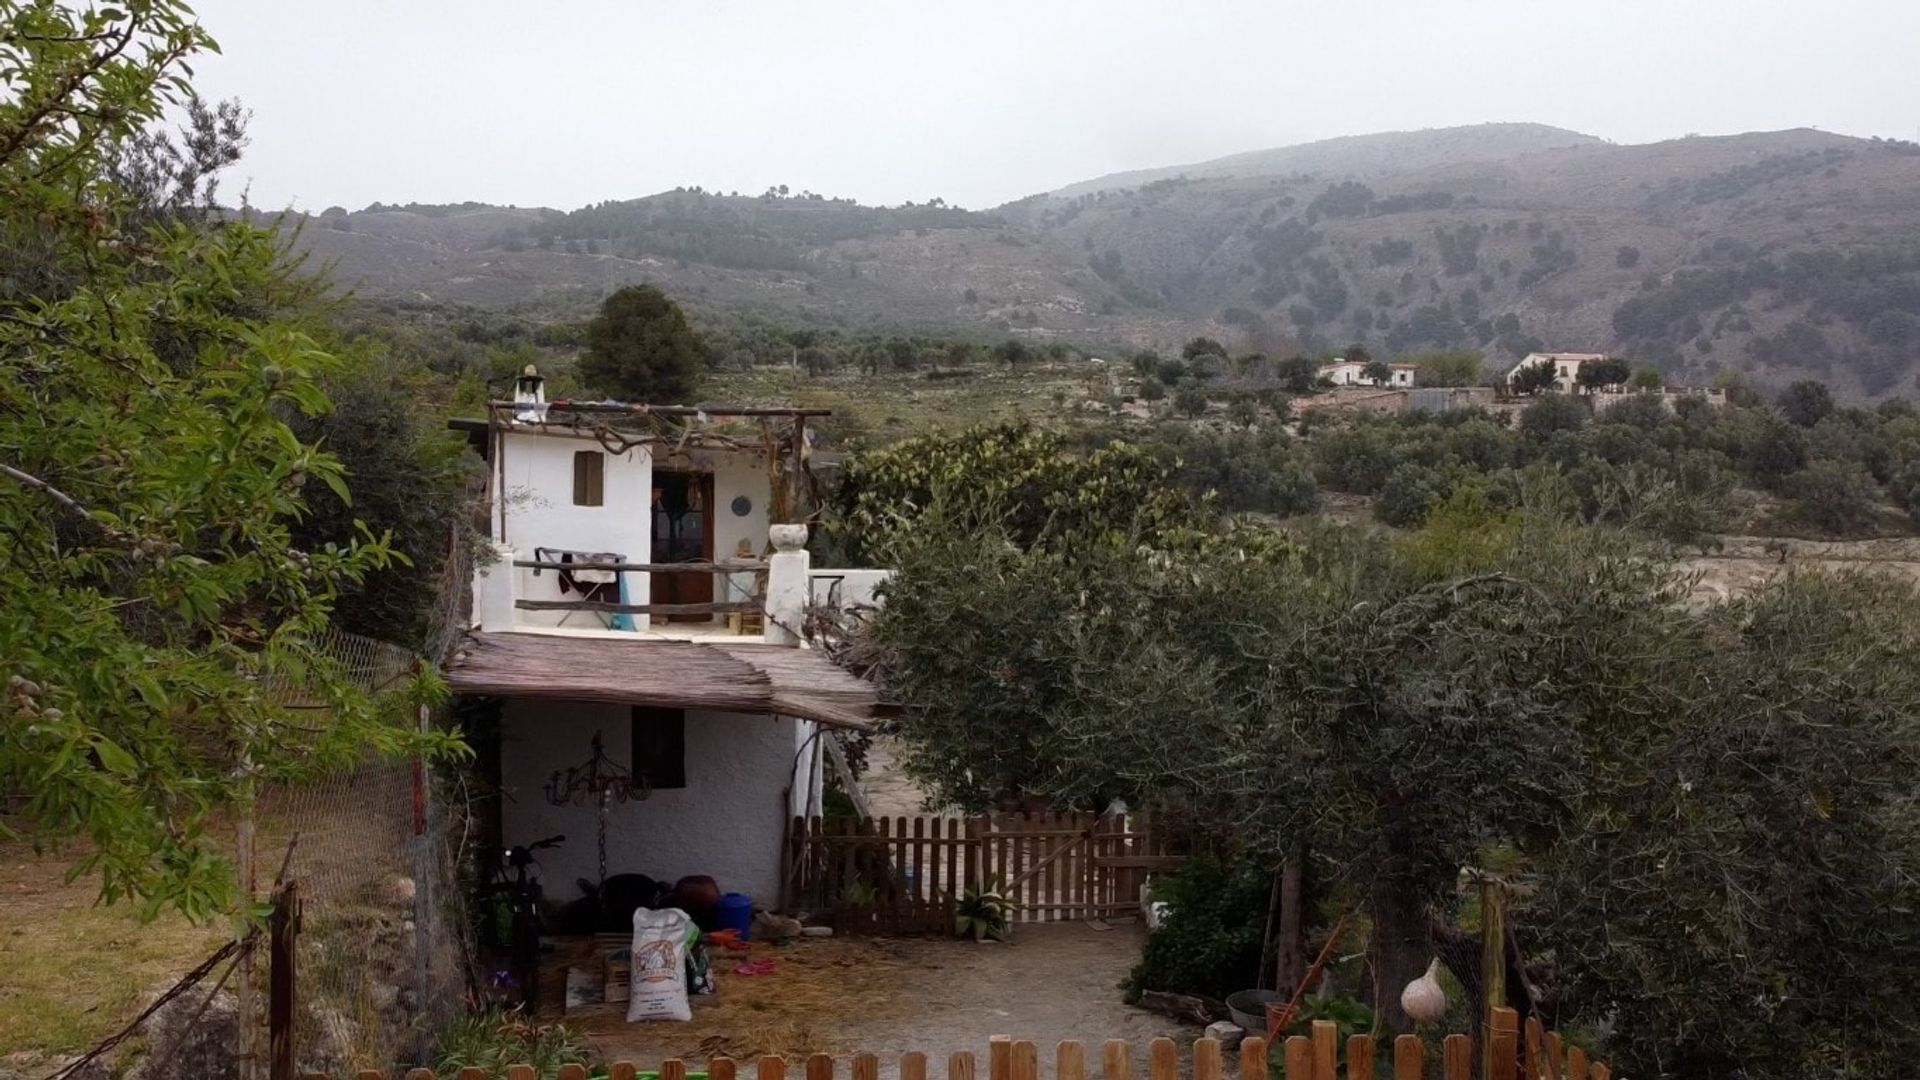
<box><xmin>196</xmin><ymin>0</ymin><xmax>1920</xmax><ymax>211</ymax></box>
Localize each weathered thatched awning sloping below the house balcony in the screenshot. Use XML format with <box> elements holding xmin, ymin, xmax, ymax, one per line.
<box><xmin>447</xmin><ymin>632</ymin><xmax>876</xmax><ymax>728</ymax></box>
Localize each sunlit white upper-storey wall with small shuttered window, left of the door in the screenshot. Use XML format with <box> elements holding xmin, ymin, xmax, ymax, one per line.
<box><xmin>495</xmin><ymin>430</ymin><xmax>653</xmax><ymax>628</ymax></box>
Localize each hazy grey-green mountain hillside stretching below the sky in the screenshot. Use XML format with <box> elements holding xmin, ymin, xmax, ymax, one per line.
<box><xmin>291</xmin><ymin>125</ymin><xmax>1920</xmax><ymax>396</ymax></box>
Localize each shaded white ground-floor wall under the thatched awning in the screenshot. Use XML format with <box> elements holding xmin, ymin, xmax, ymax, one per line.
<box><xmin>501</xmin><ymin>699</ymin><xmax>818</xmax><ymax>907</ymax></box>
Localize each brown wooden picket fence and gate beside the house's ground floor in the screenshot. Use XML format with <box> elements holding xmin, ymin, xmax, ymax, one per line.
<box><xmin>785</xmin><ymin>813</ymin><xmax>1181</xmax><ymax>934</ymax></box>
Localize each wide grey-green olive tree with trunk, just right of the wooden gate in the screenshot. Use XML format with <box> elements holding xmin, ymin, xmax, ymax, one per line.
<box><xmin>874</xmin><ymin>478</ymin><xmax>1667</xmax><ymax>1026</ymax></box>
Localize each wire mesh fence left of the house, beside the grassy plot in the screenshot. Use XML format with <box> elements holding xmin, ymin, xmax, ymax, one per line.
<box><xmin>238</xmin><ymin>530</ymin><xmax>478</xmax><ymax>1080</ymax></box>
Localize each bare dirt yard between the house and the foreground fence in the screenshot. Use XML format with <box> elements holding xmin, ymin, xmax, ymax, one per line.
<box><xmin>566</xmin><ymin>922</ymin><xmax>1196</xmax><ymax>1076</ymax></box>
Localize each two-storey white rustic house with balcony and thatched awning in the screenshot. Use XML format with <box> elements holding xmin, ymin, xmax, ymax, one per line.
<box><xmin>447</xmin><ymin>373</ymin><xmax>885</xmax><ymax>907</ymax></box>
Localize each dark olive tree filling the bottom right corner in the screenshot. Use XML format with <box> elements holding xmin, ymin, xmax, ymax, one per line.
<box><xmin>1521</xmin><ymin>575</ymin><xmax>1920</xmax><ymax>1078</ymax></box>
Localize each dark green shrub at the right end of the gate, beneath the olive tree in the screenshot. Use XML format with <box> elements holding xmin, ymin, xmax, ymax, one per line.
<box><xmin>1127</xmin><ymin>857</ymin><xmax>1273</xmax><ymax>1001</ymax></box>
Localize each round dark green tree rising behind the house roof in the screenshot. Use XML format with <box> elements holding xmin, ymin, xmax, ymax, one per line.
<box><xmin>578</xmin><ymin>284</ymin><xmax>708</xmax><ymax>405</ymax></box>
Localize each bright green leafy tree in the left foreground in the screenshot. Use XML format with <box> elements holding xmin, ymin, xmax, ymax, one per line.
<box><xmin>0</xmin><ymin>0</ymin><xmax>456</xmax><ymax>917</ymax></box>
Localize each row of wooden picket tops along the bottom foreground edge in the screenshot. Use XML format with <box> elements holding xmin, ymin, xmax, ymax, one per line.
<box><xmin>326</xmin><ymin>1009</ymin><xmax>1613</xmax><ymax>1080</ymax></box>
